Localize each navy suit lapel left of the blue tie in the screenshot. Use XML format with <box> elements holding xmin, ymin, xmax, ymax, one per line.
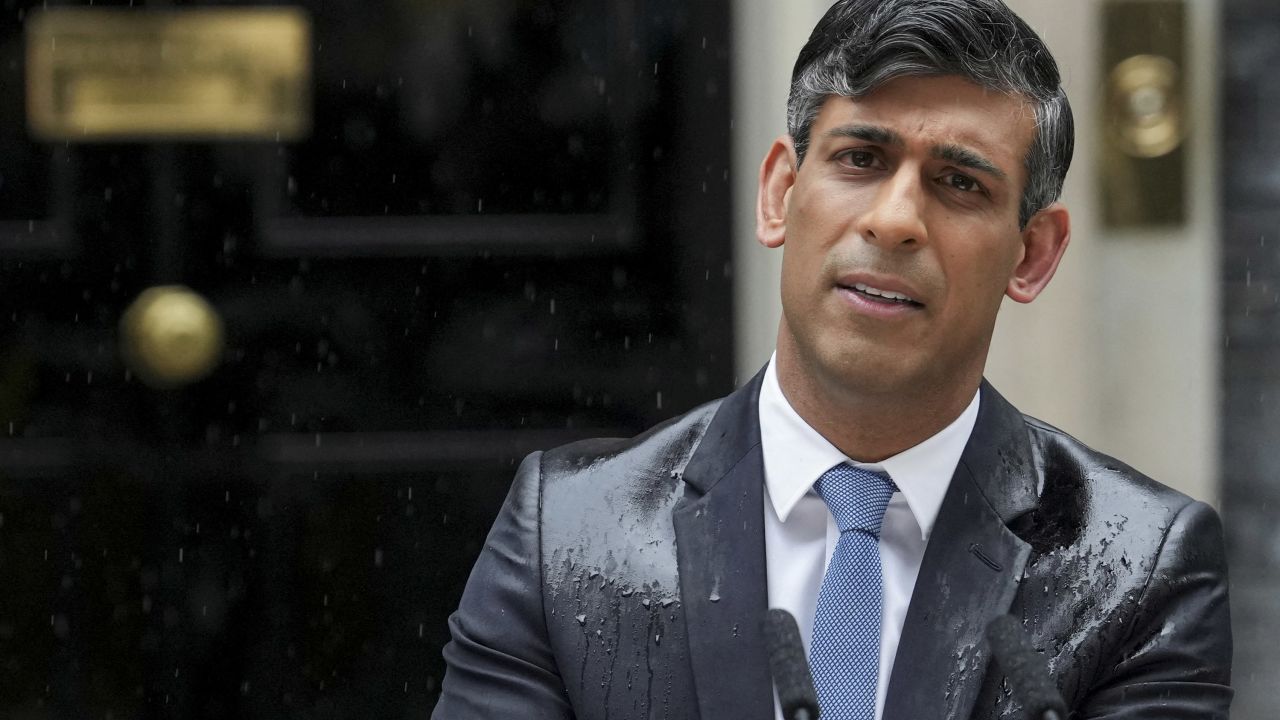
<box><xmin>673</xmin><ymin>373</ymin><xmax>773</xmax><ymax>720</ymax></box>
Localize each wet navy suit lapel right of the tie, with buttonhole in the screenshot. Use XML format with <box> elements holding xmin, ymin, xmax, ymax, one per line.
<box><xmin>883</xmin><ymin>382</ymin><xmax>1041</xmax><ymax>720</ymax></box>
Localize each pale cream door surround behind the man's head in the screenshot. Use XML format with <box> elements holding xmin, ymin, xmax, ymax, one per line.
<box><xmin>733</xmin><ymin>0</ymin><xmax>1220</xmax><ymax>502</ymax></box>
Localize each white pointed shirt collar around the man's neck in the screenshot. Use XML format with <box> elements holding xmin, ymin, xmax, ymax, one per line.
<box><xmin>759</xmin><ymin>355</ymin><xmax>980</xmax><ymax>541</ymax></box>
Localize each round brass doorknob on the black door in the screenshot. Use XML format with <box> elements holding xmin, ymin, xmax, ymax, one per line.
<box><xmin>120</xmin><ymin>286</ymin><xmax>223</xmax><ymax>389</ymax></box>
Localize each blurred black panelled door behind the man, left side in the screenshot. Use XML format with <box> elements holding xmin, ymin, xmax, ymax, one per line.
<box><xmin>0</xmin><ymin>0</ymin><xmax>732</xmax><ymax>719</ymax></box>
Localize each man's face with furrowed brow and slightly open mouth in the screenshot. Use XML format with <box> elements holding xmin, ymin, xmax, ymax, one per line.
<box><xmin>762</xmin><ymin>77</ymin><xmax>1049</xmax><ymax>396</ymax></box>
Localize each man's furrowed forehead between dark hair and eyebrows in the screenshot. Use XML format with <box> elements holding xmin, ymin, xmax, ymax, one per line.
<box><xmin>810</xmin><ymin>76</ymin><xmax>1036</xmax><ymax>174</ymax></box>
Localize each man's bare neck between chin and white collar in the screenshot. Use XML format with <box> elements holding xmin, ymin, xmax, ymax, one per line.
<box><xmin>777</xmin><ymin>352</ymin><xmax>982</xmax><ymax>462</ymax></box>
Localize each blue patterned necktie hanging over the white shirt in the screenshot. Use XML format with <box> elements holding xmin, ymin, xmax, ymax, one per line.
<box><xmin>809</xmin><ymin>462</ymin><xmax>897</xmax><ymax>720</ymax></box>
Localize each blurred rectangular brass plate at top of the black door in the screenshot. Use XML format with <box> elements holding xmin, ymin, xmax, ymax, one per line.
<box><xmin>27</xmin><ymin>8</ymin><xmax>311</xmax><ymax>142</ymax></box>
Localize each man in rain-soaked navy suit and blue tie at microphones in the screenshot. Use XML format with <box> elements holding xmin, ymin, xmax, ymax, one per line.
<box><xmin>434</xmin><ymin>0</ymin><xmax>1231</xmax><ymax>720</ymax></box>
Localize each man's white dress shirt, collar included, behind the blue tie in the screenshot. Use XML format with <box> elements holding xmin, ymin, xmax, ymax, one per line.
<box><xmin>760</xmin><ymin>356</ymin><xmax>980</xmax><ymax>720</ymax></box>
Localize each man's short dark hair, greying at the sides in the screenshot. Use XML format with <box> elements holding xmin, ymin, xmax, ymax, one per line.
<box><xmin>787</xmin><ymin>0</ymin><xmax>1075</xmax><ymax>227</ymax></box>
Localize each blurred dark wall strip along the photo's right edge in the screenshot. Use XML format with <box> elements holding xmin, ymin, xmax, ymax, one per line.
<box><xmin>1219</xmin><ymin>0</ymin><xmax>1280</xmax><ymax>720</ymax></box>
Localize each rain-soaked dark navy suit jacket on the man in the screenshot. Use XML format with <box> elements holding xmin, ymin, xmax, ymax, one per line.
<box><xmin>433</xmin><ymin>375</ymin><xmax>1231</xmax><ymax>720</ymax></box>
